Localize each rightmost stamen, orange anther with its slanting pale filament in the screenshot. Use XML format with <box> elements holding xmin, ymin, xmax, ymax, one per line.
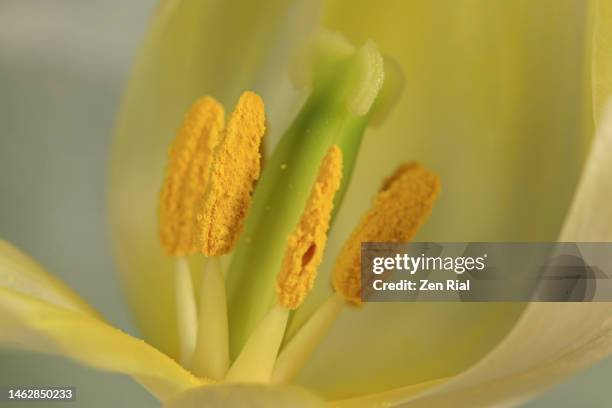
<box><xmin>271</xmin><ymin>163</ymin><xmax>440</xmax><ymax>383</ymax></box>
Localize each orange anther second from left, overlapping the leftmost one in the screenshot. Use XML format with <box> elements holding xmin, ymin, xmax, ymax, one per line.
<box><xmin>196</xmin><ymin>92</ymin><xmax>265</xmax><ymax>256</ymax></box>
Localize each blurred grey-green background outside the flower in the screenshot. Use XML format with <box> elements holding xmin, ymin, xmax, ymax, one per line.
<box><xmin>0</xmin><ymin>0</ymin><xmax>612</xmax><ymax>408</ymax></box>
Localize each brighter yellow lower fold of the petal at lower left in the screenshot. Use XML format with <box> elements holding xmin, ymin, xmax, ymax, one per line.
<box><xmin>0</xmin><ymin>289</ymin><xmax>204</xmax><ymax>399</ymax></box>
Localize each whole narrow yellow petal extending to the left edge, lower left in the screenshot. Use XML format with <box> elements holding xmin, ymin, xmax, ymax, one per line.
<box><xmin>0</xmin><ymin>242</ymin><xmax>202</xmax><ymax>399</ymax></box>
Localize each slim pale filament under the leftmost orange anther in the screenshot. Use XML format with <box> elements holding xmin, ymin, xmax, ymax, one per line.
<box><xmin>174</xmin><ymin>257</ymin><xmax>198</xmax><ymax>368</ymax></box>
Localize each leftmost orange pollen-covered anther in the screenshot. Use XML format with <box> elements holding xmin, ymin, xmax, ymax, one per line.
<box><xmin>159</xmin><ymin>96</ymin><xmax>224</xmax><ymax>255</ymax></box>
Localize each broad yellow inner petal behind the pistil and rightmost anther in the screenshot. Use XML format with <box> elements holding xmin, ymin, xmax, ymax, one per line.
<box><xmin>290</xmin><ymin>0</ymin><xmax>592</xmax><ymax>398</ymax></box>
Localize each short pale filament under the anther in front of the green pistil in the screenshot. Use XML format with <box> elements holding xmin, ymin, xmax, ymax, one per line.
<box><xmin>225</xmin><ymin>304</ymin><xmax>289</xmax><ymax>383</ymax></box>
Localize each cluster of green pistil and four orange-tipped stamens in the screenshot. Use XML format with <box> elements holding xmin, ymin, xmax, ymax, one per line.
<box><xmin>159</xmin><ymin>28</ymin><xmax>439</xmax><ymax>383</ymax></box>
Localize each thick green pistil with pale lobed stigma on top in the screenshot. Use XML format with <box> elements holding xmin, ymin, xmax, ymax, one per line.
<box><xmin>227</xmin><ymin>32</ymin><xmax>401</xmax><ymax>358</ymax></box>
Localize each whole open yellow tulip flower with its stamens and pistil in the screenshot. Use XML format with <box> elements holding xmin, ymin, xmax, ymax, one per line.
<box><xmin>0</xmin><ymin>0</ymin><xmax>612</xmax><ymax>407</ymax></box>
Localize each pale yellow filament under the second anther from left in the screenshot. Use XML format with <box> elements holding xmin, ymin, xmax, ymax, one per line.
<box><xmin>192</xmin><ymin>258</ymin><xmax>229</xmax><ymax>380</ymax></box>
